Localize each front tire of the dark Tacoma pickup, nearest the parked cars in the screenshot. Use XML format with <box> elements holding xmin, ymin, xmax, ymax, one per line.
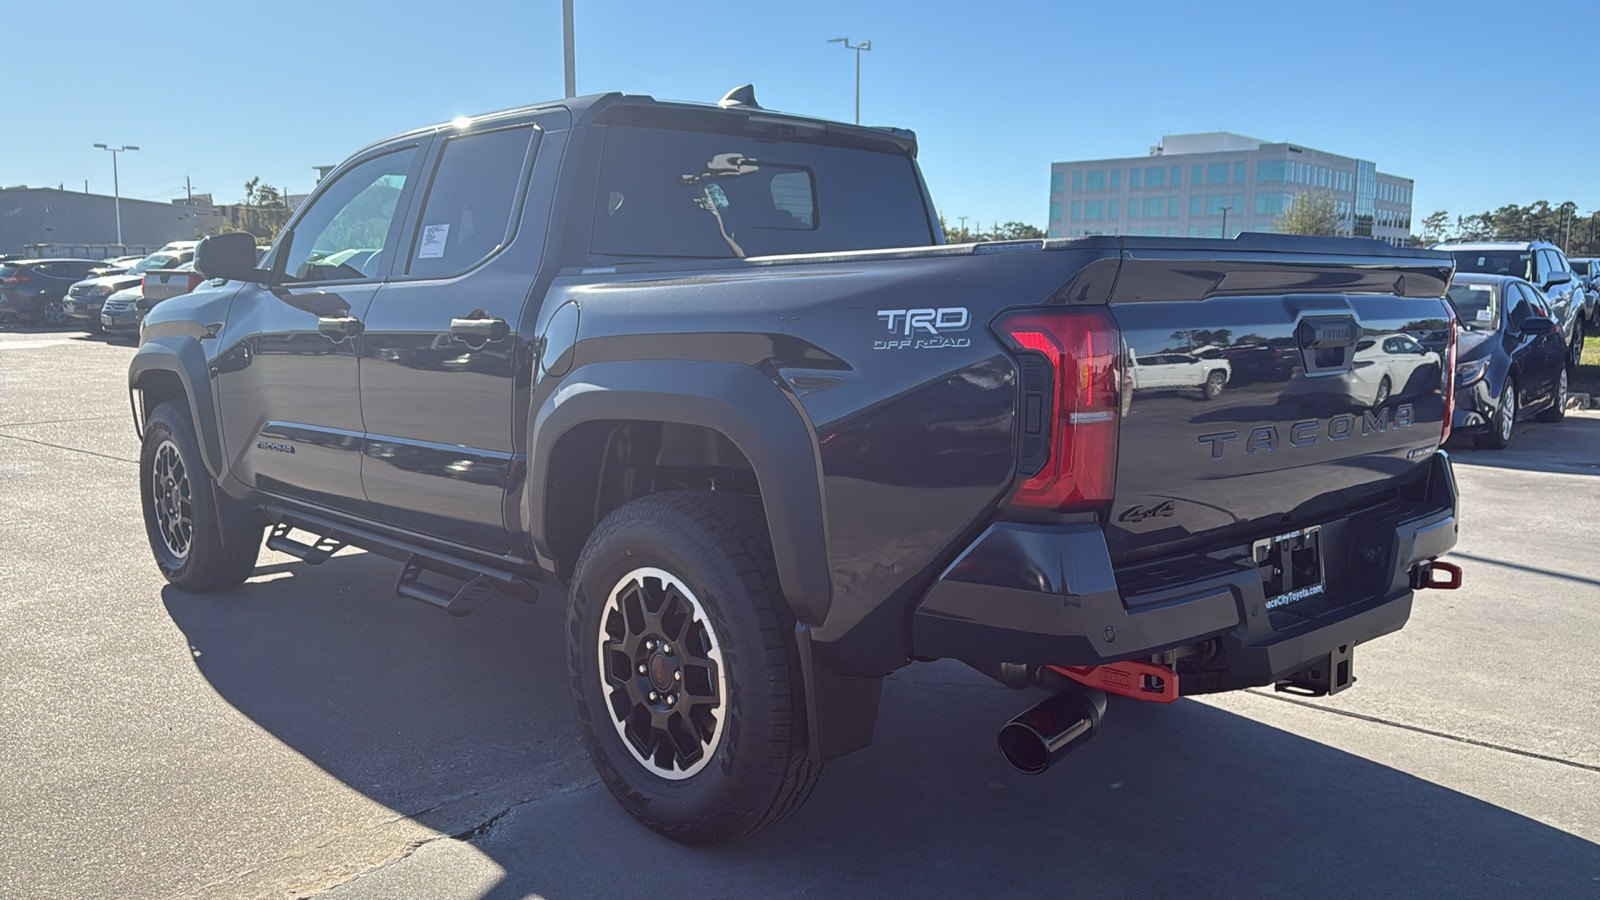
<box><xmin>139</xmin><ymin>400</ymin><xmax>266</xmax><ymax>593</ymax></box>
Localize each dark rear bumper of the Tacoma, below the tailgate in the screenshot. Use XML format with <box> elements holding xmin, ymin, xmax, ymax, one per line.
<box><xmin>912</xmin><ymin>452</ymin><xmax>1456</xmax><ymax>687</ymax></box>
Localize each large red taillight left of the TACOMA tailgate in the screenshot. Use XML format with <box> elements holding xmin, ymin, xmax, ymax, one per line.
<box><xmin>995</xmin><ymin>309</ymin><xmax>1122</xmax><ymax>509</ymax></box>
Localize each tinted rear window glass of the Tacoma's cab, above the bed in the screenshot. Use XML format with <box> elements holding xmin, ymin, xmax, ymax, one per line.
<box><xmin>590</xmin><ymin>125</ymin><xmax>933</xmax><ymax>259</ymax></box>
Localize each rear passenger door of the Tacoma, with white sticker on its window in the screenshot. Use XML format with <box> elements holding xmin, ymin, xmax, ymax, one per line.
<box><xmin>360</xmin><ymin>123</ymin><xmax>549</xmax><ymax>554</ymax></box>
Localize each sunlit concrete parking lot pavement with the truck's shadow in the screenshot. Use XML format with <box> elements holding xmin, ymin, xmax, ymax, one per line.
<box><xmin>0</xmin><ymin>328</ymin><xmax>1600</xmax><ymax>900</ymax></box>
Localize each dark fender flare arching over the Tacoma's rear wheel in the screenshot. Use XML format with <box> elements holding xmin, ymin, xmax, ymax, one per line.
<box><xmin>523</xmin><ymin>360</ymin><xmax>832</xmax><ymax>625</ymax></box>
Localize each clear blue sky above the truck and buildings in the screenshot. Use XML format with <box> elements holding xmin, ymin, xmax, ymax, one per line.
<box><xmin>0</xmin><ymin>0</ymin><xmax>1600</xmax><ymax>227</ymax></box>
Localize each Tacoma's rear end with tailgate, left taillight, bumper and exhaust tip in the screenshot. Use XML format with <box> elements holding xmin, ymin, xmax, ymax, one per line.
<box><xmin>914</xmin><ymin>235</ymin><xmax>1459</xmax><ymax>772</ymax></box>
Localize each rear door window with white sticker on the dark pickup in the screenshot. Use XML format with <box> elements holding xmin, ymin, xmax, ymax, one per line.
<box><xmin>406</xmin><ymin>127</ymin><xmax>534</xmax><ymax>277</ymax></box>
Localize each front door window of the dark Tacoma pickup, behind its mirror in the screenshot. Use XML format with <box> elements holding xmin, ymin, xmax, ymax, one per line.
<box><xmin>283</xmin><ymin>147</ymin><xmax>416</xmax><ymax>282</ymax></box>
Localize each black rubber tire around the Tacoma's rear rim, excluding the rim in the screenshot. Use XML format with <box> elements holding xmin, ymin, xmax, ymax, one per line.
<box><xmin>566</xmin><ymin>492</ymin><xmax>822</xmax><ymax>844</ymax></box>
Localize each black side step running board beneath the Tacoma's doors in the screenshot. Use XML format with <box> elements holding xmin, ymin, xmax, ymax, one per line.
<box><xmin>257</xmin><ymin>504</ymin><xmax>549</xmax><ymax>617</ymax></box>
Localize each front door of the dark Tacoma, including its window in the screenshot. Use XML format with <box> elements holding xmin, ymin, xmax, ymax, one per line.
<box><xmin>216</xmin><ymin>144</ymin><xmax>421</xmax><ymax>514</ymax></box>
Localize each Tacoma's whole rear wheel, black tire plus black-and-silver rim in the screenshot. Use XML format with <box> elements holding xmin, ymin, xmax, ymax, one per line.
<box><xmin>566</xmin><ymin>492</ymin><xmax>822</xmax><ymax>844</ymax></box>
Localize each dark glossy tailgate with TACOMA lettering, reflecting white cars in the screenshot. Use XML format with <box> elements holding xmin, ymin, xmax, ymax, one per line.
<box><xmin>1106</xmin><ymin>242</ymin><xmax>1450</xmax><ymax>562</ymax></box>
